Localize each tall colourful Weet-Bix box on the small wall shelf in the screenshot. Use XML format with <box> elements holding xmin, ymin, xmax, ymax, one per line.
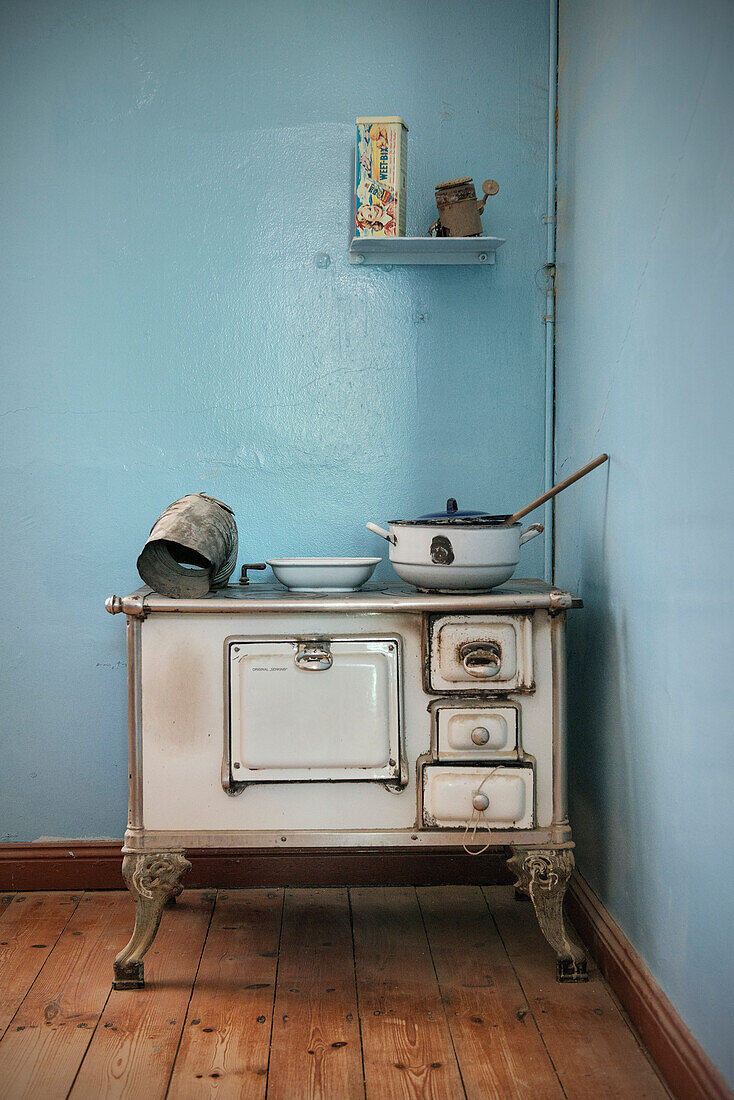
<box><xmin>354</xmin><ymin>116</ymin><xmax>408</xmax><ymax>237</ymax></box>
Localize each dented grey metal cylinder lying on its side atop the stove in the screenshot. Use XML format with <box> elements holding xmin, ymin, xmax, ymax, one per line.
<box><xmin>138</xmin><ymin>493</ymin><xmax>238</xmax><ymax>600</ymax></box>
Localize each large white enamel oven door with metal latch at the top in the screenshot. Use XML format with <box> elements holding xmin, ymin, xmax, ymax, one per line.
<box><xmin>222</xmin><ymin>636</ymin><xmax>407</xmax><ymax>790</ymax></box>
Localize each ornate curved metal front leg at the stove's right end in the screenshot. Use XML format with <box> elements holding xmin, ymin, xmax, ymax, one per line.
<box><xmin>507</xmin><ymin>848</ymin><xmax>589</xmax><ymax>981</ymax></box>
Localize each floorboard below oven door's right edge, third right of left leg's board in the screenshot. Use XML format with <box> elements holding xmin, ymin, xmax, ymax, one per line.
<box><xmin>350</xmin><ymin>887</ymin><xmax>464</xmax><ymax>1100</ymax></box>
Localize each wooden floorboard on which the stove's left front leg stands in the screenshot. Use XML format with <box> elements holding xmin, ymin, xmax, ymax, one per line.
<box><xmin>70</xmin><ymin>890</ymin><xmax>215</xmax><ymax>1100</ymax></box>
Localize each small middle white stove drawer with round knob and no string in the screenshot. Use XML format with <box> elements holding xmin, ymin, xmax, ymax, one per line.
<box><xmin>436</xmin><ymin>705</ymin><xmax>517</xmax><ymax>760</ymax></box>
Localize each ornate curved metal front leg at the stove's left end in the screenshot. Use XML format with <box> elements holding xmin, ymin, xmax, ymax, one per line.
<box><xmin>112</xmin><ymin>851</ymin><xmax>191</xmax><ymax>989</ymax></box>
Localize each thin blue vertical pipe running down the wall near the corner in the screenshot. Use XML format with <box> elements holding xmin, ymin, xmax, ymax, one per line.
<box><xmin>544</xmin><ymin>0</ymin><xmax>558</xmax><ymax>583</ymax></box>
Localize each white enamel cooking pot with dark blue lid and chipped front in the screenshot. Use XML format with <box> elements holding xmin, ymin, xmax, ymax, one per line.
<box><xmin>366</xmin><ymin>499</ymin><xmax>543</xmax><ymax>592</ymax></box>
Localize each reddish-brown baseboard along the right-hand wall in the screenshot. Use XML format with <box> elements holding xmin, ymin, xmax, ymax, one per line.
<box><xmin>566</xmin><ymin>871</ymin><xmax>734</xmax><ymax>1100</ymax></box>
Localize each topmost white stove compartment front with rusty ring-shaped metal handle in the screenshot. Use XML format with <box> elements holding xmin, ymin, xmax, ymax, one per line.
<box><xmin>428</xmin><ymin>615</ymin><xmax>535</xmax><ymax>693</ymax></box>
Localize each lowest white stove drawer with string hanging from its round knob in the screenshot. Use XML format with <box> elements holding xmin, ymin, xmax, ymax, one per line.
<box><xmin>423</xmin><ymin>765</ymin><xmax>533</xmax><ymax>829</ymax></box>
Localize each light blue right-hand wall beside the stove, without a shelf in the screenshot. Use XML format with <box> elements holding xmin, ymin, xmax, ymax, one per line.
<box><xmin>556</xmin><ymin>0</ymin><xmax>734</xmax><ymax>1084</ymax></box>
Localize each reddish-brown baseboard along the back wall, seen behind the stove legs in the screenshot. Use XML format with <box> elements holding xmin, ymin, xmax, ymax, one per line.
<box><xmin>0</xmin><ymin>840</ymin><xmax>514</xmax><ymax>891</ymax></box>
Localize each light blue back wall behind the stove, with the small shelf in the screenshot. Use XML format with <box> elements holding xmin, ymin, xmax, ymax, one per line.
<box><xmin>0</xmin><ymin>0</ymin><xmax>548</xmax><ymax>840</ymax></box>
